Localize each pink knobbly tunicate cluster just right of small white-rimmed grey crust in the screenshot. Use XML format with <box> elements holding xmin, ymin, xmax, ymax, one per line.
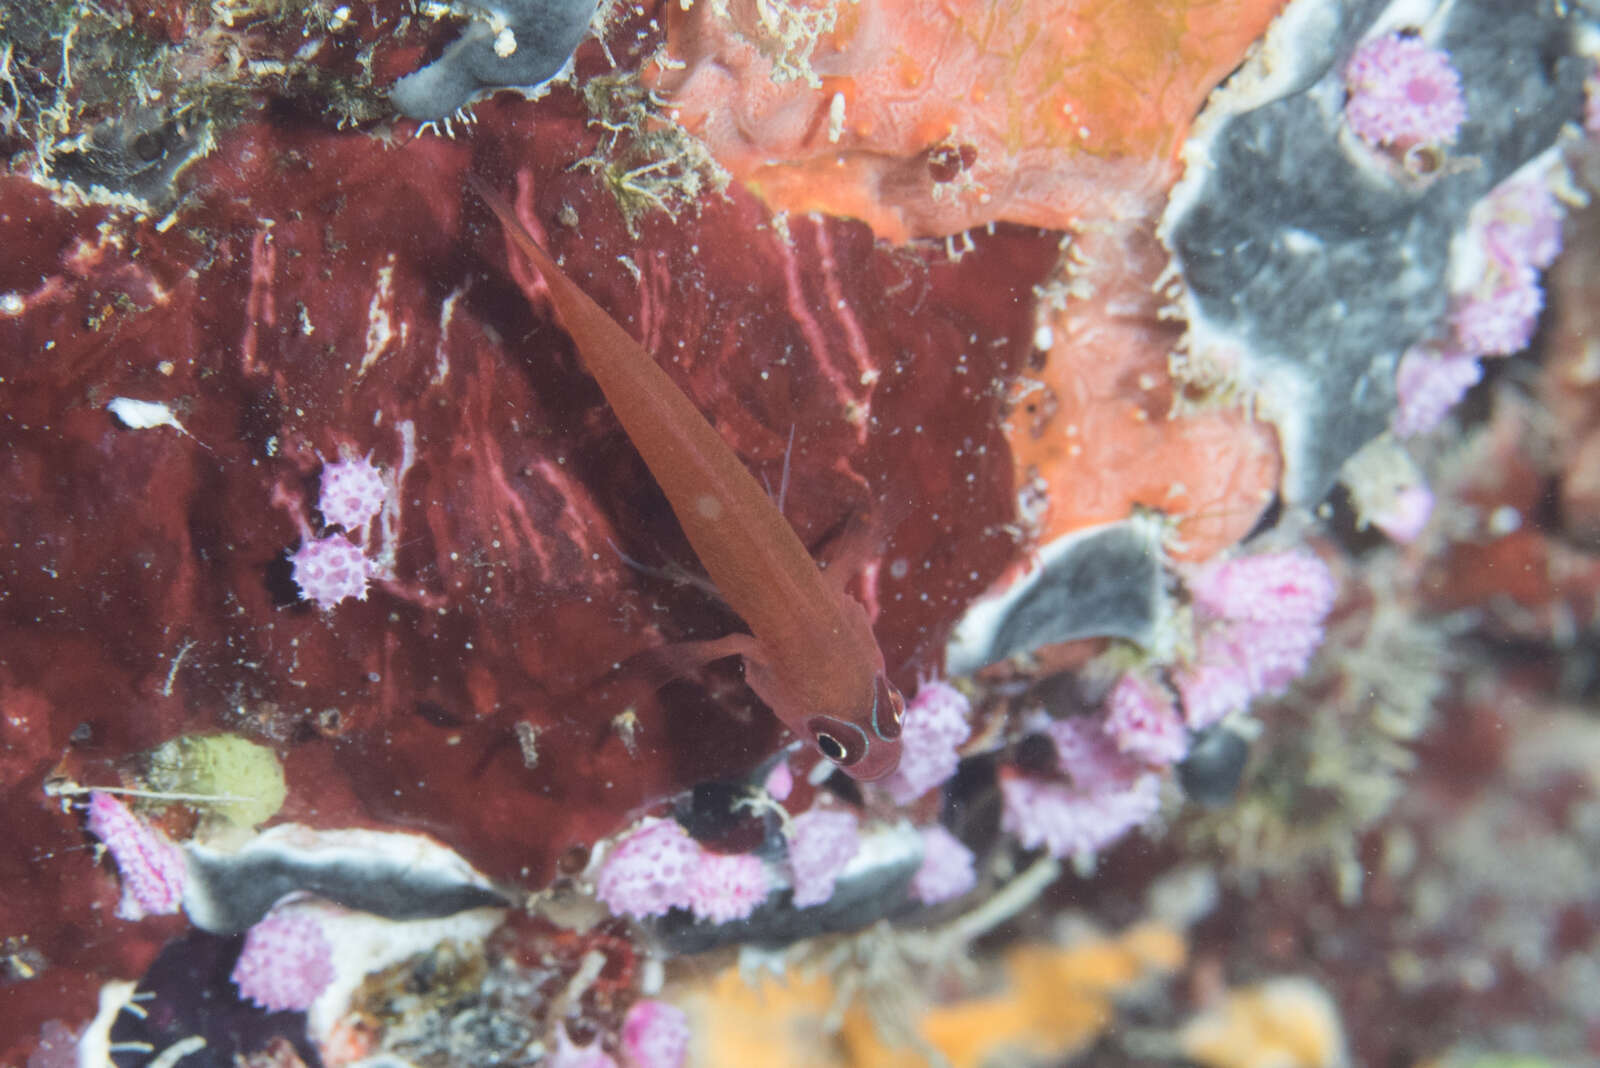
<box><xmin>1176</xmin><ymin>552</ymin><xmax>1338</xmax><ymax>731</ymax></box>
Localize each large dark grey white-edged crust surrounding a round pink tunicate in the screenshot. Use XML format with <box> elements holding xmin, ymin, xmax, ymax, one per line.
<box><xmin>1162</xmin><ymin>0</ymin><xmax>1589</xmax><ymax>505</ymax></box>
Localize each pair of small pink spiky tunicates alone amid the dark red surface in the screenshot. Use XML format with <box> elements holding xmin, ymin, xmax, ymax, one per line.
<box><xmin>290</xmin><ymin>457</ymin><xmax>389</xmax><ymax>609</ymax></box>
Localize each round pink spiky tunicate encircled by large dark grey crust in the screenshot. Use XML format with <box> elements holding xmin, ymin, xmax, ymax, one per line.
<box><xmin>1344</xmin><ymin>34</ymin><xmax>1467</xmax><ymax>152</ymax></box>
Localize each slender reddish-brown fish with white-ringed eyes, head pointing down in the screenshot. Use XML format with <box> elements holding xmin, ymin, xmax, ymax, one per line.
<box><xmin>472</xmin><ymin>181</ymin><xmax>906</xmax><ymax>779</ymax></box>
